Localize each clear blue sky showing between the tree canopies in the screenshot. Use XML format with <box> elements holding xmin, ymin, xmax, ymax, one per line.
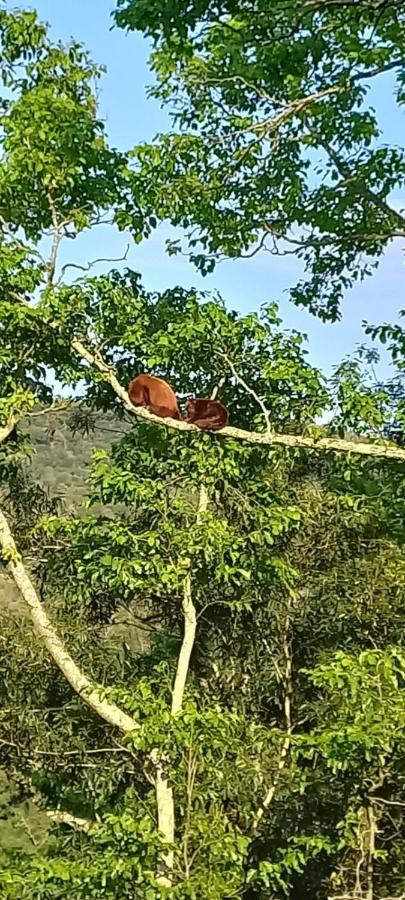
<box><xmin>6</xmin><ymin>0</ymin><xmax>405</xmax><ymax>374</ymax></box>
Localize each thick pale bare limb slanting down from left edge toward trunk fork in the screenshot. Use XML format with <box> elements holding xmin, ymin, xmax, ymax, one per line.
<box><xmin>0</xmin><ymin>510</ymin><xmax>140</xmax><ymax>732</ymax></box>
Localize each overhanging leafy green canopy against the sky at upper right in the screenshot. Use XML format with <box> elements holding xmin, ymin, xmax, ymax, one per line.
<box><xmin>116</xmin><ymin>0</ymin><xmax>405</xmax><ymax>319</ymax></box>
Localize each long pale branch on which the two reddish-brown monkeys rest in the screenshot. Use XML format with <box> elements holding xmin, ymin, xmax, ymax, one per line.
<box><xmin>72</xmin><ymin>340</ymin><xmax>405</xmax><ymax>462</ymax></box>
